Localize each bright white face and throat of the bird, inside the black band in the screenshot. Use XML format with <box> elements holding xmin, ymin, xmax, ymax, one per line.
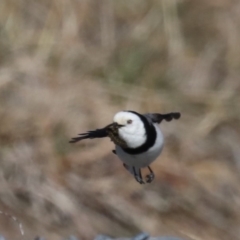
<box><xmin>113</xmin><ymin>111</ymin><xmax>147</xmax><ymax>148</ymax></box>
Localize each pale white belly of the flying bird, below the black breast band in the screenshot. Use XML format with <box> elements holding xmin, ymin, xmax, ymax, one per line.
<box><xmin>116</xmin><ymin>124</ymin><xmax>164</xmax><ymax>168</ymax></box>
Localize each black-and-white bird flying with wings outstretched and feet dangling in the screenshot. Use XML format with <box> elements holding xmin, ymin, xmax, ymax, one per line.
<box><xmin>69</xmin><ymin>110</ymin><xmax>181</xmax><ymax>184</ymax></box>
